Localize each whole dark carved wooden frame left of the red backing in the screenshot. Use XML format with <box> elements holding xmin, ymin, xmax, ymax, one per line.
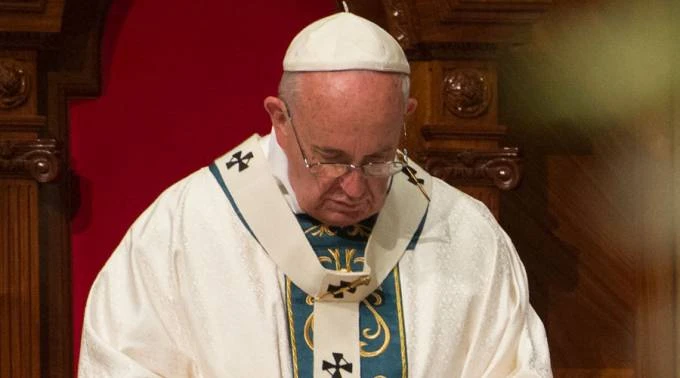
<box><xmin>0</xmin><ymin>0</ymin><xmax>108</xmax><ymax>378</ymax></box>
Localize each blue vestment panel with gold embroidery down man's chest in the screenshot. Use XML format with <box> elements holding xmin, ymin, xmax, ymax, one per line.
<box><xmin>286</xmin><ymin>214</ymin><xmax>422</xmax><ymax>378</ymax></box>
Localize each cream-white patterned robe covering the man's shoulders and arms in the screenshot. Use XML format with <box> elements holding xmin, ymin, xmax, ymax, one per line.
<box><xmin>79</xmin><ymin>134</ymin><xmax>552</xmax><ymax>378</ymax></box>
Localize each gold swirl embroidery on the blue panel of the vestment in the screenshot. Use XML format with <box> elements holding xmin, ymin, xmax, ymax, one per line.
<box><xmin>303</xmin><ymin>247</ymin><xmax>392</xmax><ymax>357</ymax></box>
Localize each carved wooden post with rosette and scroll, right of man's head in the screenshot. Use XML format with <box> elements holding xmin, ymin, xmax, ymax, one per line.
<box><xmin>406</xmin><ymin>56</ymin><xmax>510</xmax><ymax>216</ymax></box>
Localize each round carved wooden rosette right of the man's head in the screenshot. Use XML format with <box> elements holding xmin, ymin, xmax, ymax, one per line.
<box><xmin>443</xmin><ymin>69</ymin><xmax>492</xmax><ymax>118</ymax></box>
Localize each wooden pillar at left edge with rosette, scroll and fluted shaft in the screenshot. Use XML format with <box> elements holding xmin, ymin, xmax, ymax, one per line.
<box><xmin>0</xmin><ymin>50</ymin><xmax>54</xmax><ymax>377</ymax></box>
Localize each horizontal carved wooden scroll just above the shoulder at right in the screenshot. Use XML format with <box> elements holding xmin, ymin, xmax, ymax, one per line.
<box><xmin>418</xmin><ymin>148</ymin><xmax>522</xmax><ymax>190</ymax></box>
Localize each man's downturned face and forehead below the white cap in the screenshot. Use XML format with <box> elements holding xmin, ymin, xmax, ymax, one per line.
<box><xmin>275</xmin><ymin>71</ymin><xmax>405</xmax><ymax>226</ymax></box>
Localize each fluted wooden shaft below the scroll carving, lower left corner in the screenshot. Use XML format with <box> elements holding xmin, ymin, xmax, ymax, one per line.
<box><xmin>0</xmin><ymin>179</ymin><xmax>40</xmax><ymax>377</ymax></box>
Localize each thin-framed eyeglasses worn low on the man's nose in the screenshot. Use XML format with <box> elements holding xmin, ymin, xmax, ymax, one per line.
<box><xmin>287</xmin><ymin>114</ymin><xmax>408</xmax><ymax>178</ymax></box>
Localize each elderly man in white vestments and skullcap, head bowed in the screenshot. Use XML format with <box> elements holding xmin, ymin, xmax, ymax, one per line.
<box><xmin>79</xmin><ymin>13</ymin><xmax>551</xmax><ymax>378</ymax></box>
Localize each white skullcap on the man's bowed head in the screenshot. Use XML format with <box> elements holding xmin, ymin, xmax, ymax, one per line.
<box><xmin>283</xmin><ymin>12</ymin><xmax>411</xmax><ymax>74</ymax></box>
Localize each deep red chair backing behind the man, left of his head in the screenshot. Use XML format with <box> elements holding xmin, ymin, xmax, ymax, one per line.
<box><xmin>70</xmin><ymin>0</ymin><xmax>335</xmax><ymax>368</ymax></box>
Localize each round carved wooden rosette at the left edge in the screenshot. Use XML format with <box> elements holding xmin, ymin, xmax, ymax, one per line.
<box><xmin>0</xmin><ymin>59</ymin><xmax>31</xmax><ymax>110</ymax></box>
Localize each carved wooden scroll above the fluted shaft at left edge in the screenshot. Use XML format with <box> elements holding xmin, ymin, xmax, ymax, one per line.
<box><xmin>0</xmin><ymin>139</ymin><xmax>61</xmax><ymax>183</ymax></box>
